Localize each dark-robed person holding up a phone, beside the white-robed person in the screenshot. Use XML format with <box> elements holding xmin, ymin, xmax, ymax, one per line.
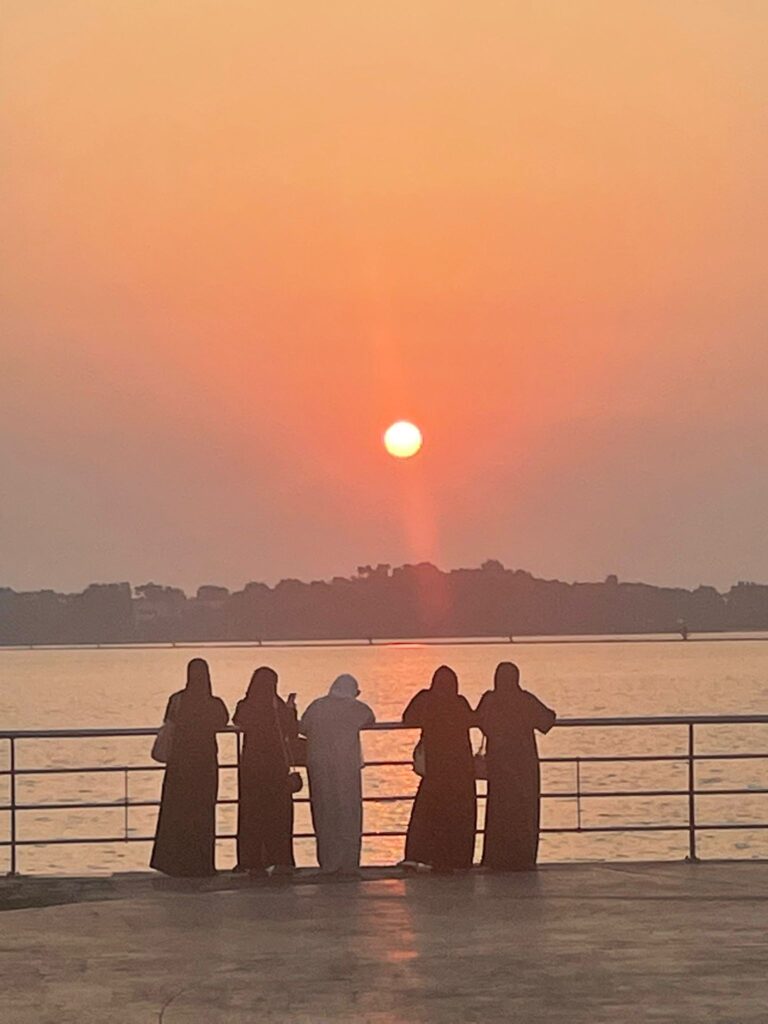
<box><xmin>232</xmin><ymin>666</ymin><xmax>298</xmax><ymax>873</ymax></box>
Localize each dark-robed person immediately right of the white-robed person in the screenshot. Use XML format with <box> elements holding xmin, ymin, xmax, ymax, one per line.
<box><xmin>402</xmin><ymin>665</ymin><xmax>476</xmax><ymax>871</ymax></box>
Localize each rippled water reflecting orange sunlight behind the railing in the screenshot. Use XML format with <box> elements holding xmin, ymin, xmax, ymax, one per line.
<box><xmin>0</xmin><ymin>638</ymin><xmax>768</xmax><ymax>873</ymax></box>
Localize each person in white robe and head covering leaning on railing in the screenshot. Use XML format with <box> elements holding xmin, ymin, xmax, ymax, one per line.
<box><xmin>299</xmin><ymin>675</ymin><xmax>376</xmax><ymax>874</ymax></box>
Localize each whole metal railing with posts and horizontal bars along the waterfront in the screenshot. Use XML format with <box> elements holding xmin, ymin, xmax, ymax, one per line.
<box><xmin>0</xmin><ymin>715</ymin><xmax>768</xmax><ymax>876</ymax></box>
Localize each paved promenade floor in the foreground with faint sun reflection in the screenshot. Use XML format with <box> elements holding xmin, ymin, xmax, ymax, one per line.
<box><xmin>0</xmin><ymin>862</ymin><xmax>768</xmax><ymax>1024</ymax></box>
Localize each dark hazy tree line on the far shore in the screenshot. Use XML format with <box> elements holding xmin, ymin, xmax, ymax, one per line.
<box><xmin>0</xmin><ymin>560</ymin><xmax>768</xmax><ymax>645</ymax></box>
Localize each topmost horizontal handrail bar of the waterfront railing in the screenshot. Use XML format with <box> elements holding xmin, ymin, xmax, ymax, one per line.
<box><xmin>0</xmin><ymin>715</ymin><xmax>768</xmax><ymax>739</ymax></box>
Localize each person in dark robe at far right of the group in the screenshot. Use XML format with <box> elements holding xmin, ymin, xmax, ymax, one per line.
<box><xmin>477</xmin><ymin>662</ymin><xmax>555</xmax><ymax>871</ymax></box>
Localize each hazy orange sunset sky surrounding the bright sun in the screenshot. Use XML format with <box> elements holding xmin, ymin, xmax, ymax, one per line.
<box><xmin>0</xmin><ymin>0</ymin><xmax>768</xmax><ymax>589</ymax></box>
